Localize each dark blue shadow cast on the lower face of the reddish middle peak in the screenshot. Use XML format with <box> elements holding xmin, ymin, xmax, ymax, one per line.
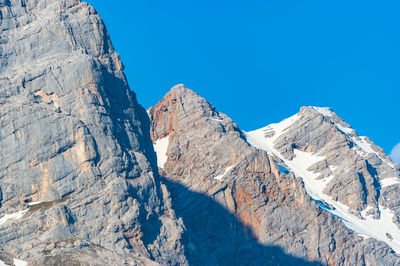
<box><xmin>163</xmin><ymin>178</ymin><xmax>322</xmax><ymax>265</ymax></box>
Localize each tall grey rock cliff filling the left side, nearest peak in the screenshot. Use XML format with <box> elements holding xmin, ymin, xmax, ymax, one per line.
<box><xmin>0</xmin><ymin>0</ymin><xmax>186</xmax><ymax>265</ymax></box>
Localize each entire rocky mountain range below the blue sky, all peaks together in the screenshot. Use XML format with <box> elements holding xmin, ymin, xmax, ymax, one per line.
<box><xmin>0</xmin><ymin>0</ymin><xmax>400</xmax><ymax>265</ymax></box>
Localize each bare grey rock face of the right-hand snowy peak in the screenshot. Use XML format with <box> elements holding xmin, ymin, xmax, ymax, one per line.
<box><xmin>274</xmin><ymin>107</ymin><xmax>400</xmax><ymax>216</ymax></box>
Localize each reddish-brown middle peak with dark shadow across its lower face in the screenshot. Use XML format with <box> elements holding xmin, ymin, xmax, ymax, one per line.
<box><xmin>148</xmin><ymin>85</ymin><xmax>400</xmax><ymax>265</ymax></box>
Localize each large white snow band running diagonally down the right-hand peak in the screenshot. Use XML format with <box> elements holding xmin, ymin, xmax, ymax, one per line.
<box><xmin>245</xmin><ymin>110</ymin><xmax>400</xmax><ymax>254</ymax></box>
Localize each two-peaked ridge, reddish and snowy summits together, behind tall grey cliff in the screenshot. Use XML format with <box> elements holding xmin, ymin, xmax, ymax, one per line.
<box><xmin>148</xmin><ymin>85</ymin><xmax>400</xmax><ymax>265</ymax></box>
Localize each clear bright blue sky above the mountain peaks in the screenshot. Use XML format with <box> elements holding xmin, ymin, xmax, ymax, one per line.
<box><xmin>87</xmin><ymin>0</ymin><xmax>400</xmax><ymax>153</ymax></box>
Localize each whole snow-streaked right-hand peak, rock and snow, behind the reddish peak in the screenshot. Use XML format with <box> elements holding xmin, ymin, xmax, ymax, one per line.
<box><xmin>246</xmin><ymin>107</ymin><xmax>400</xmax><ymax>253</ymax></box>
